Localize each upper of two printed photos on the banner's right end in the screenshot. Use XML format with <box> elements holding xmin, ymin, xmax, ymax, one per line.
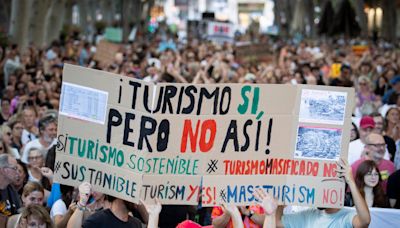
<box><xmin>299</xmin><ymin>89</ymin><xmax>347</xmax><ymax>125</ymax></box>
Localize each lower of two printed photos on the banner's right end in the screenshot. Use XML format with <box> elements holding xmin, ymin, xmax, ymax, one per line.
<box><xmin>294</xmin><ymin>126</ymin><xmax>342</xmax><ymax>161</ymax></box>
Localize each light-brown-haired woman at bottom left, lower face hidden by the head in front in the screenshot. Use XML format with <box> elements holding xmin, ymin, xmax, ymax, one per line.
<box><xmin>7</xmin><ymin>182</ymin><xmax>44</xmax><ymax>228</ymax></box>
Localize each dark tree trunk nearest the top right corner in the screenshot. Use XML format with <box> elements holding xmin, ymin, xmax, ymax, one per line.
<box><xmin>382</xmin><ymin>0</ymin><xmax>397</xmax><ymax>41</ymax></box>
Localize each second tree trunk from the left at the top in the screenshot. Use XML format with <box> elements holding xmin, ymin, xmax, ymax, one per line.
<box><xmin>30</xmin><ymin>0</ymin><xmax>51</xmax><ymax>48</ymax></box>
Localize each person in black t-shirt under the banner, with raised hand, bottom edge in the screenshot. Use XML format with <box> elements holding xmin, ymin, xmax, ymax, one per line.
<box><xmin>79</xmin><ymin>196</ymin><xmax>161</xmax><ymax>228</ymax></box>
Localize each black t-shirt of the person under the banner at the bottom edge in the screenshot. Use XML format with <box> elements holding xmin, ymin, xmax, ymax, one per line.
<box><xmin>82</xmin><ymin>209</ymin><xmax>142</xmax><ymax>228</ymax></box>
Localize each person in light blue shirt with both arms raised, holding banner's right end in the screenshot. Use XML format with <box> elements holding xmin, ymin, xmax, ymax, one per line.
<box><xmin>254</xmin><ymin>160</ymin><xmax>371</xmax><ymax>228</ymax></box>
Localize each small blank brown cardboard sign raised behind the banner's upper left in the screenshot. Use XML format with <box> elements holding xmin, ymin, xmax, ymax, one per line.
<box><xmin>93</xmin><ymin>40</ymin><xmax>120</xmax><ymax>67</ymax></box>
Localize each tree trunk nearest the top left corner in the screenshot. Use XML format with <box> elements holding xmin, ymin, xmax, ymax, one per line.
<box><xmin>9</xmin><ymin>0</ymin><xmax>32</xmax><ymax>51</ymax></box>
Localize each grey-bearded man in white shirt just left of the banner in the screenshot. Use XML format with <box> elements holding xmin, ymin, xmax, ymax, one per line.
<box><xmin>21</xmin><ymin>116</ymin><xmax>57</xmax><ymax>164</ymax></box>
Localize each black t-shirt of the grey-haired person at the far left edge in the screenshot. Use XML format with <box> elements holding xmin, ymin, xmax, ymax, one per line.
<box><xmin>0</xmin><ymin>185</ymin><xmax>21</xmax><ymax>216</ymax></box>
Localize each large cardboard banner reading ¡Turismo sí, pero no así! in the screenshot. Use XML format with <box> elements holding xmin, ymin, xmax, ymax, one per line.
<box><xmin>55</xmin><ymin>64</ymin><xmax>354</xmax><ymax>207</ymax></box>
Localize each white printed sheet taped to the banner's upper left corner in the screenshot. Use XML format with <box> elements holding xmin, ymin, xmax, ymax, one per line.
<box><xmin>60</xmin><ymin>82</ymin><xmax>108</xmax><ymax>124</ymax></box>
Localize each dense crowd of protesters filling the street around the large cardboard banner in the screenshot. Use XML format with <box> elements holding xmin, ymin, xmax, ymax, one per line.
<box><xmin>0</xmin><ymin>27</ymin><xmax>400</xmax><ymax>228</ymax></box>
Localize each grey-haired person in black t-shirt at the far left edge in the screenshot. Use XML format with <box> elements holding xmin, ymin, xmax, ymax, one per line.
<box><xmin>0</xmin><ymin>154</ymin><xmax>21</xmax><ymax>216</ymax></box>
